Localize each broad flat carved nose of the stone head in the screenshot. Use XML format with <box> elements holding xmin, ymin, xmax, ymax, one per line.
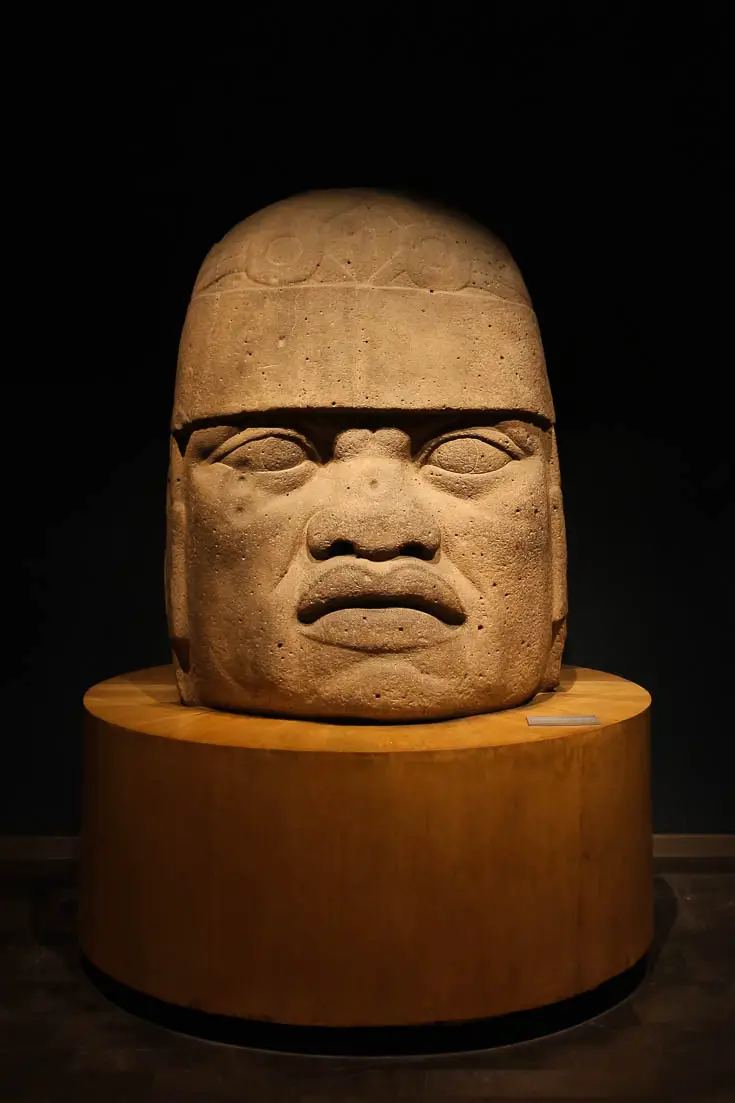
<box><xmin>307</xmin><ymin>510</ymin><xmax>439</xmax><ymax>563</ymax></box>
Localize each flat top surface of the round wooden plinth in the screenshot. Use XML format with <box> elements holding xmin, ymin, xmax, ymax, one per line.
<box><xmin>84</xmin><ymin>665</ymin><xmax>651</xmax><ymax>754</ymax></box>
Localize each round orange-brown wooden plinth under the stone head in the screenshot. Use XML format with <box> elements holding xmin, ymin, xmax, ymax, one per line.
<box><xmin>81</xmin><ymin>667</ymin><xmax>652</xmax><ymax>1026</ymax></box>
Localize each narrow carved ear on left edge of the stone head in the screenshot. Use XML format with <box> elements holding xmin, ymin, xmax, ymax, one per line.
<box><xmin>164</xmin><ymin>437</ymin><xmax>190</xmax><ymax>700</ymax></box>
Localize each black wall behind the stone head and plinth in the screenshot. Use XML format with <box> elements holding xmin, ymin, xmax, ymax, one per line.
<box><xmin>0</xmin><ymin>4</ymin><xmax>735</xmax><ymax>834</ymax></box>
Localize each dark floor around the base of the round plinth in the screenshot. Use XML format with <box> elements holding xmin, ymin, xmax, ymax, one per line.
<box><xmin>0</xmin><ymin>859</ymin><xmax>735</xmax><ymax>1103</ymax></box>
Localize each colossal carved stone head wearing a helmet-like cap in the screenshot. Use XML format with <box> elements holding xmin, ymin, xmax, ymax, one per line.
<box><xmin>167</xmin><ymin>190</ymin><xmax>566</xmax><ymax>720</ymax></box>
